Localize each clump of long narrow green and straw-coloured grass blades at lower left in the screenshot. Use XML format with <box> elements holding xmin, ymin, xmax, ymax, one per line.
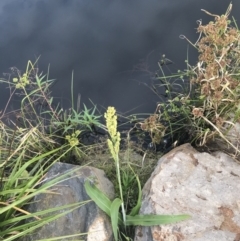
<box><xmin>0</xmin><ymin>108</ymin><xmax>90</xmax><ymax>241</ymax></box>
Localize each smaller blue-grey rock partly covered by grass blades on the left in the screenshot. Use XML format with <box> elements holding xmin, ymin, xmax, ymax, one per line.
<box><xmin>22</xmin><ymin>163</ymin><xmax>114</xmax><ymax>241</ymax></box>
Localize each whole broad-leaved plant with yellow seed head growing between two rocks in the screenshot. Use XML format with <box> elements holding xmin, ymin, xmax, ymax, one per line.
<box><xmin>85</xmin><ymin>107</ymin><xmax>190</xmax><ymax>241</ymax></box>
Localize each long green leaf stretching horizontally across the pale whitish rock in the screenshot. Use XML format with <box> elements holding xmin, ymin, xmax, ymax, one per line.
<box><xmin>126</xmin><ymin>214</ymin><xmax>191</xmax><ymax>226</ymax></box>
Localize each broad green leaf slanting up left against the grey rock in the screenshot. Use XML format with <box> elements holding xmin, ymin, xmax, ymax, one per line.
<box><xmin>84</xmin><ymin>180</ymin><xmax>111</xmax><ymax>217</ymax></box>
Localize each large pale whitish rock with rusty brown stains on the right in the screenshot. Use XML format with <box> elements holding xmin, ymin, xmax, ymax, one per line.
<box><xmin>135</xmin><ymin>144</ymin><xmax>240</xmax><ymax>241</ymax></box>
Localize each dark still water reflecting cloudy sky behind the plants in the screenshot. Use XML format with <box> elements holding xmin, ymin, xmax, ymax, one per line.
<box><xmin>0</xmin><ymin>0</ymin><xmax>236</xmax><ymax>115</ymax></box>
